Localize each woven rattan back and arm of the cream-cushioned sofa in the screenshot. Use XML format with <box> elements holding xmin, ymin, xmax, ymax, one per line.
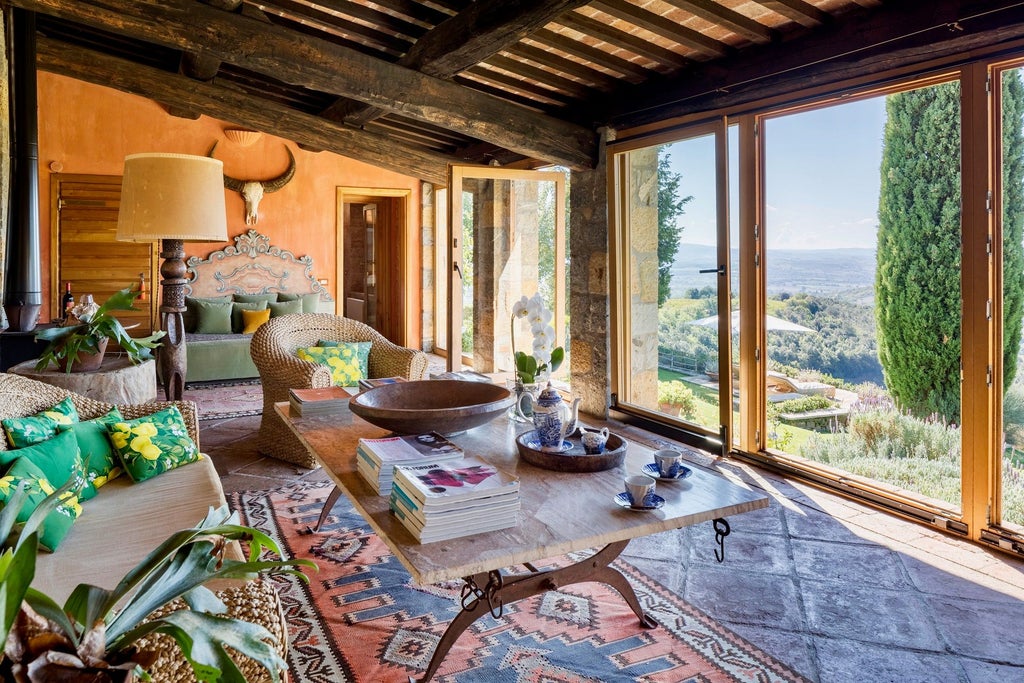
<box><xmin>0</xmin><ymin>373</ymin><xmax>288</xmax><ymax>683</ymax></box>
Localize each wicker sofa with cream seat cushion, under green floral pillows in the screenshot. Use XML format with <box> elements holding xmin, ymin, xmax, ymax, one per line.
<box><xmin>0</xmin><ymin>373</ymin><xmax>288</xmax><ymax>682</ymax></box>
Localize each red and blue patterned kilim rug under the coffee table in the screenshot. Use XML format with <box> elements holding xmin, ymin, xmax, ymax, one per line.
<box><xmin>230</xmin><ymin>483</ymin><xmax>805</xmax><ymax>683</ymax></box>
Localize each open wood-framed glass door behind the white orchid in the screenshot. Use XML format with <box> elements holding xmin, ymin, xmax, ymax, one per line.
<box><xmin>446</xmin><ymin>166</ymin><xmax>568</xmax><ymax>377</ymax></box>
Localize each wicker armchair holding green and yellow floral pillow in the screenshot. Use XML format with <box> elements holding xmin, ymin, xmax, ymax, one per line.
<box><xmin>249</xmin><ymin>313</ymin><xmax>427</xmax><ymax>468</ymax></box>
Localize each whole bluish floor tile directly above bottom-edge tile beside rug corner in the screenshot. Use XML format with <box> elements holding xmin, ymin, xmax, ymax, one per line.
<box><xmin>800</xmin><ymin>580</ymin><xmax>945</xmax><ymax>651</ymax></box>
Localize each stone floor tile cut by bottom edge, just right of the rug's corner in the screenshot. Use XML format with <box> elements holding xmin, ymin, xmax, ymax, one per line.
<box><xmin>814</xmin><ymin>638</ymin><xmax>966</xmax><ymax>683</ymax></box>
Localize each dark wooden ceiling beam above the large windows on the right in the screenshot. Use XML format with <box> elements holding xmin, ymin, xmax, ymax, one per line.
<box><xmin>608</xmin><ymin>0</ymin><xmax>1024</xmax><ymax>129</ymax></box>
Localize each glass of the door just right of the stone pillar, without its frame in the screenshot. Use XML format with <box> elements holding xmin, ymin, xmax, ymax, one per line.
<box><xmin>628</xmin><ymin>134</ymin><xmax>731</xmax><ymax>433</ymax></box>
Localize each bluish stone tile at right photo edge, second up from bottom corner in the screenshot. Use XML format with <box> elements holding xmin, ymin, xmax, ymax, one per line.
<box><xmin>927</xmin><ymin>596</ymin><xmax>1024</xmax><ymax>667</ymax></box>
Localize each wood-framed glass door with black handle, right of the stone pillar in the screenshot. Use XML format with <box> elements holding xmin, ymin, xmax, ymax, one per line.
<box><xmin>613</xmin><ymin>121</ymin><xmax>739</xmax><ymax>449</ymax></box>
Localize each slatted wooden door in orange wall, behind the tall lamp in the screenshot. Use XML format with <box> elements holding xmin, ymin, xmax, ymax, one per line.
<box><xmin>50</xmin><ymin>174</ymin><xmax>159</xmax><ymax>337</ymax></box>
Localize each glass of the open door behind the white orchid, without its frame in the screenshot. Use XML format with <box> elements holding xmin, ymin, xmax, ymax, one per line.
<box><xmin>461</xmin><ymin>178</ymin><xmax>568</xmax><ymax>381</ymax></box>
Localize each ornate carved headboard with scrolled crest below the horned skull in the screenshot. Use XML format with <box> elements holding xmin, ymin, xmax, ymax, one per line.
<box><xmin>185</xmin><ymin>229</ymin><xmax>334</xmax><ymax>310</ymax></box>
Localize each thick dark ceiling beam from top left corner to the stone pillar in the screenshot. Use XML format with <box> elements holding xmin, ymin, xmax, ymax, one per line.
<box><xmin>14</xmin><ymin>0</ymin><xmax>597</xmax><ymax>169</ymax></box>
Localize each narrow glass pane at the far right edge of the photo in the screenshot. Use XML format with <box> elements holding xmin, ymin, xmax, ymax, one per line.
<box><xmin>999</xmin><ymin>69</ymin><xmax>1024</xmax><ymax>531</ymax></box>
